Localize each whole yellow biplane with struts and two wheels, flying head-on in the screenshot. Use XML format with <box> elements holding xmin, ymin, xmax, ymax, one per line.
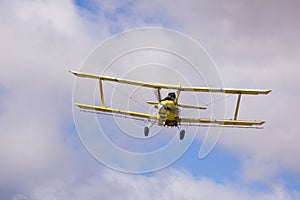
<box><xmin>70</xmin><ymin>71</ymin><xmax>271</xmax><ymax>140</ymax></box>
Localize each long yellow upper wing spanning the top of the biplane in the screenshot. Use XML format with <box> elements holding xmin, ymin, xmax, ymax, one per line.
<box><xmin>70</xmin><ymin>71</ymin><xmax>271</xmax><ymax>95</ymax></box>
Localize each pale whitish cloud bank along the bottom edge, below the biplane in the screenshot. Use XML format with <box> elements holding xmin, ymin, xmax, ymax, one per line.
<box><xmin>27</xmin><ymin>169</ymin><xmax>299</xmax><ymax>200</ymax></box>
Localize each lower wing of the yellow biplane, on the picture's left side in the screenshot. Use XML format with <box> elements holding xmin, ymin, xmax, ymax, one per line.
<box><xmin>75</xmin><ymin>103</ymin><xmax>156</xmax><ymax>119</ymax></box>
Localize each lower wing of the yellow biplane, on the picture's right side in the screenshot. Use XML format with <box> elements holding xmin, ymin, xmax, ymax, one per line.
<box><xmin>179</xmin><ymin>118</ymin><xmax>265</xmax><ymax>126</ymax></box>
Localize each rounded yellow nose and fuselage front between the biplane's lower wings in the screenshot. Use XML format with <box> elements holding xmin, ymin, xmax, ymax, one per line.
<box><xmin>157</xmin><ymin>100</ymin><xmax>179</xmax><ymax>126</ymax></box>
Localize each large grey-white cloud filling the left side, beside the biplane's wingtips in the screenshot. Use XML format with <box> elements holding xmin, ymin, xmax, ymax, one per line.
<box><xmin>0</xmin><ymin>1</ymin><xmax>98</xmax><ymax>181</ymax></box>
